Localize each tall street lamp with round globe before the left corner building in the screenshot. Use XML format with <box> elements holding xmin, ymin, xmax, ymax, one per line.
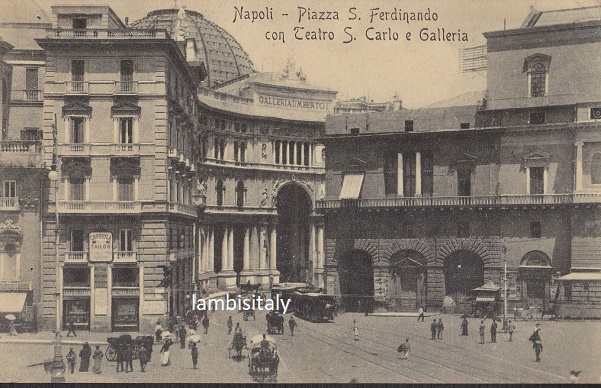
<box><xmin>48</xmin><ymin>165</ymin><xmax>65</xmax><ymax>384</ymax></box>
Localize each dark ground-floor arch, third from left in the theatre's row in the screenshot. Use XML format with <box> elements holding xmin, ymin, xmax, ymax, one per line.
<box><xmin>443</xmin><ymin>250</ymin><xmax>484</xmax><ymax>313</ymax></box>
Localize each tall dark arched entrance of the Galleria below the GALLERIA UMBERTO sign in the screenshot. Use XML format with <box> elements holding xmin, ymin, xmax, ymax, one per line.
<box><xmin>276</xmin><ymin>184</ymin><xmax>313</xmax><ymax>282</ymax></box>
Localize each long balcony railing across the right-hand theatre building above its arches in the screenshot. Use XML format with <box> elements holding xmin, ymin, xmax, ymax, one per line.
<box><xmin>317</xmin><ymin>193</ymin><xmax>601</xmax><ymax>210</ymax></box>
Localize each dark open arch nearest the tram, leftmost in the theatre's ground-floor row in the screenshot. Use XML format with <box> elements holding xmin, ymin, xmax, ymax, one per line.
<box><xmin>338</xmin><ymin>250</ymin><xmax>374</xmax><ymax>312</ymax></box>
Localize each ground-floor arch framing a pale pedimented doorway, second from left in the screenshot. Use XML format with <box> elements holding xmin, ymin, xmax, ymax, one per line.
<box><xmin>388</xmin><ymin>250</ymin><xmax>427</xmax><ymax>311</ymax></box>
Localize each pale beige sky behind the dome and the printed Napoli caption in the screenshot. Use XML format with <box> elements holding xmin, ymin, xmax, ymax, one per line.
<box><xmin>31</xmin><ymin>0</ymin><xmax>601</xmax><ymax>108</ymax></box>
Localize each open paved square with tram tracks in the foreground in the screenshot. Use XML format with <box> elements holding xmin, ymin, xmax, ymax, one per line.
<box><xmin>0</xmin><ymin>312</ymin><xmax>601</xmax><ymax>383</ymax></box>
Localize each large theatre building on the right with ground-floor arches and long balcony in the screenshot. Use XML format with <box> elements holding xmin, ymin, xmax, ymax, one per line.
<box><xmin>318</xmin><ymin>7</ymin><xmax>601</xmax><ymax>316</ymax></box>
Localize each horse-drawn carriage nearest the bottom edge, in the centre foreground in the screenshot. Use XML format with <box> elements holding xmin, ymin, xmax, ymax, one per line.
<box><xmin>248</xmin><ymin>335</ymin><xmax>280</xmax><ymax>382</ymax></box>
